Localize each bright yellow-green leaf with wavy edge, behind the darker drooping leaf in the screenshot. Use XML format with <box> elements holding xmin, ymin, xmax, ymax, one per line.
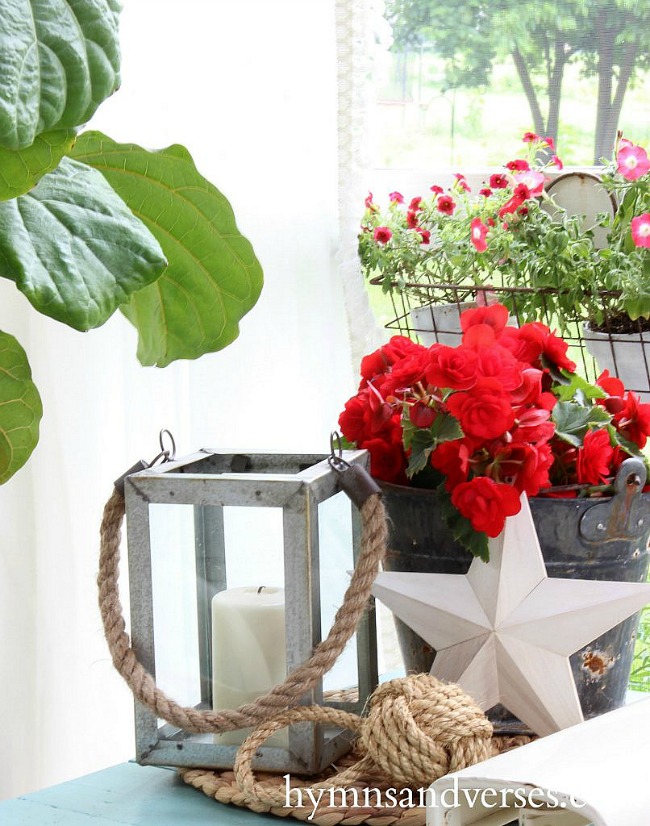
<box><xmin>73</xmin><ymin>132</ymin><xmax>262</xmax><ymax>367</ymax></box>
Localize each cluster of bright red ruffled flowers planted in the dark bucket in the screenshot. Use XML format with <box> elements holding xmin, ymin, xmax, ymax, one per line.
<box><xmin>339</xmin><ymin>304</ymin><xmax>650</xmax><ymax>548</ymax></box>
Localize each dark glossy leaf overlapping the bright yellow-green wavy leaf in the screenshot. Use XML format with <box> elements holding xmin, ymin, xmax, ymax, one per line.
<box><xmin>0</xmin><ymin>158</ymin><xmax>166</xmax><ymax>330</ymax></box>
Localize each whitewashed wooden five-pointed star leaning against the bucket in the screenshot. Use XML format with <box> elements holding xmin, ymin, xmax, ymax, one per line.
<box><xmin>373</xmin><ymin>496</ymin><xmax>650</xmax><ymax>735</ymax></box>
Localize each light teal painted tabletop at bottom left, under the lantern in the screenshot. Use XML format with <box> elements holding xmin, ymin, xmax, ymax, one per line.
<box><xmin>0</xmin><ymin>763</ymin><xmax>268</xmax><ymax>826</ymax></box>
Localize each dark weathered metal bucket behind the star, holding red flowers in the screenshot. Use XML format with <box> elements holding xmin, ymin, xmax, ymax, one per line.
<box><xmin>382</xmin><ymin>458</ymin><xmax>650</xmax><ymax>733</ymax></box>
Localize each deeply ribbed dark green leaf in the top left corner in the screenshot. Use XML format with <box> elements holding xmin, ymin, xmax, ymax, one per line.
<box><xmin>0</xmin><ymin>0</ymin><xmax>120</xmax><ymax>149</ymax></box>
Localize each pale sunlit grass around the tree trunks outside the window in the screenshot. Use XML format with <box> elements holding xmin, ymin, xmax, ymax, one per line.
<box><xmin>373</xmin><ymin>54</ymin><xmax>650</xmax><ymax>167</ymax></box>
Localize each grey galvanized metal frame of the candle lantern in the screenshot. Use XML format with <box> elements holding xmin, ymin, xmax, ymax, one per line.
<box><xmin>125</xmin><ymin>449</ymin><xmax>378</xmax><ymax>774</ymax></box>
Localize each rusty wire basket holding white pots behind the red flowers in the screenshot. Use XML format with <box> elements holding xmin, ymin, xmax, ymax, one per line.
<box><xmin>369</xmin><ymin>276</ymin><xmax>650</xmax><ymax>402</ymax></box>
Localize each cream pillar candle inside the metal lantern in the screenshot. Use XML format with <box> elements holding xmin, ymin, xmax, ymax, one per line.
<box><xmin>212</xmin><ymin>586</ymin><xmax>288</xmax><ymax>748</ymax></box>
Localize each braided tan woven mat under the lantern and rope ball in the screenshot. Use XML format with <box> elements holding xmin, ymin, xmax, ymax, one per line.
<box><xmin>179</xmin><ymin>735</ymin><xmax>532</xmax><ymax>826</ymax></box>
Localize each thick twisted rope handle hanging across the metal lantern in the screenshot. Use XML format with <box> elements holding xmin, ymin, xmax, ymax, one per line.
<box><xmin>97</xmin><ymin>438</ymin><xmax>388</xmax><ymax>733</ymax></box>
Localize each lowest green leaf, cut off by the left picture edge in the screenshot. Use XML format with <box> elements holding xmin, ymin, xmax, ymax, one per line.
<box><xmin>0</xmin><ymin>331</ymin><xmax>43</xmax><ymax>485</ymax></box>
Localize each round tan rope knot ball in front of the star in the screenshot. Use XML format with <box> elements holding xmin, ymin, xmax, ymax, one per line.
<box><xmin>359</xmin><ymin>674</ymin><xmax>492</xmax><ymax>787</ymax></box>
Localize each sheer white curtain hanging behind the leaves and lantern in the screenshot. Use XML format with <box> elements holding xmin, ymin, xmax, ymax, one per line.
<box><xmin>0</xmin><ymin>0</ymin><xmax>380</xmax><ymax>797</ymax></box>
